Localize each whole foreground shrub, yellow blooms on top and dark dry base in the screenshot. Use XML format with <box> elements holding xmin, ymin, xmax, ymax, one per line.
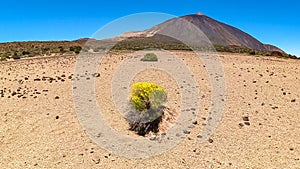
<box><xmin>128</xmin><ymin>82</ymin><xmax>167</xmax><ymax>135</ymax></box>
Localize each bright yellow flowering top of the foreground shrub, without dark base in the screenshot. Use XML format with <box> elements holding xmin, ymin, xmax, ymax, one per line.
<box><xmin>130</xmin><ymin>82</ymin><xmax>167</xmax><ymax>111</ymax></box>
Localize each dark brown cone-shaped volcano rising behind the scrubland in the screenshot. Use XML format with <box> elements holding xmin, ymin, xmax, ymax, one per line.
<box><xmin>118</xmin><ymin>12</ymin><xmax>284</xmax><ymax>53</ymax></box>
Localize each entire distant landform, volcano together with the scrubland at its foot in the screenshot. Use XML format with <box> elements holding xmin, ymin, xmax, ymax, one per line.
<box><xmin>0</xmin><ymin>13</ymin><xmax>296</xmax><ymax>61</ymax></box>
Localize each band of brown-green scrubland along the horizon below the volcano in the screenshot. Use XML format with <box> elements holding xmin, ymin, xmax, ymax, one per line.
<box><xmin>0</xmin><ymin>35</ymin><xmax>298</xmax><ymax>61</ymax></box>
